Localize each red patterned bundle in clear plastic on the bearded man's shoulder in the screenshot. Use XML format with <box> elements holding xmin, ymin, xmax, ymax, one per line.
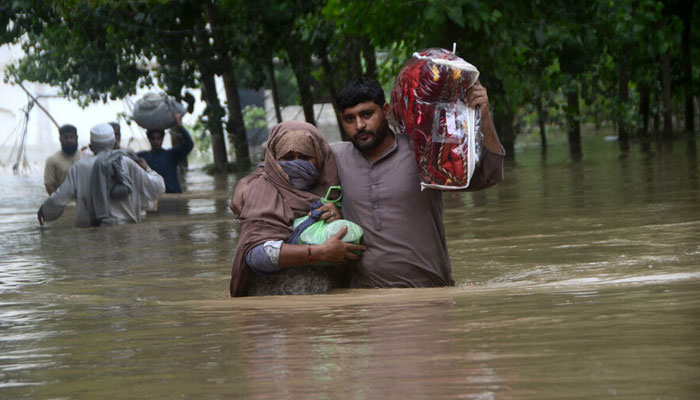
<box><xmin>391</xmin><ymin>49</ymin><xmax>483</xmax><ymax>189</ymax></box>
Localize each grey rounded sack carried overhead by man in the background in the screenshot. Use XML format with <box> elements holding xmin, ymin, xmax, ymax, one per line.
<box><xmin>131</xmin><ymin>92</ymin><xmax>186</xmax><ymax>131</ymax></box>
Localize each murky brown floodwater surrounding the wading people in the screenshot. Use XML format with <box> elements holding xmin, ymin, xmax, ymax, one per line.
<box><xmin>0</xmin><ymin>136</ymin><xmax>700</xmax><ymax>399</ymax></box>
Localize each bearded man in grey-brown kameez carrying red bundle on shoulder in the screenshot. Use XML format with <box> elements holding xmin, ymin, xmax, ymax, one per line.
<box><xmin>331</xmin><ymin>78</ymin><xmax>505</xmax><ymax>288</ymax></box>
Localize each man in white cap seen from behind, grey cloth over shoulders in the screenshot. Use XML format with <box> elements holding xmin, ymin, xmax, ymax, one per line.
<box><xmin>37</xmin><ymin>124</ymin><xmax>165</xmax><ymax>227</ymax></box>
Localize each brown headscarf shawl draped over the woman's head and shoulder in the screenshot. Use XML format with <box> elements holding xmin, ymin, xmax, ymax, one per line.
<box><xmin>230</xmin><ymin>121</ymin><xmax>338</xmax><ymax>297</ymax></box>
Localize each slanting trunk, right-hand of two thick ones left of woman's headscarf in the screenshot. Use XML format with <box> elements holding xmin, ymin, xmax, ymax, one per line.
<box><xmin>202</xmin><ymin>0</ymin><xmax>250</xmax><ymax>169</ymax></box>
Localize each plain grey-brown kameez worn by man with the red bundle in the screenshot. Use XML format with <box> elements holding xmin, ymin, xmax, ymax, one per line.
<box><xmin>331</xmin><ymin>131</ymin><xmax>503</xmax><ymax>288</ymax></box>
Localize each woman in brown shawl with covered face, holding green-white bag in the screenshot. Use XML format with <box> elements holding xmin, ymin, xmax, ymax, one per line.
<box><xmin>230</xmin><ymin>121</ymin><xmax>364</xmax><ymax>297</ymax></box>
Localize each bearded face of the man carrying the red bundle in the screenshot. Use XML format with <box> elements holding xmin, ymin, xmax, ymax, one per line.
<box><xmin>341</xmin><ymin>101</ymin><xmax>389</xmax><ymax>152</ymax></box>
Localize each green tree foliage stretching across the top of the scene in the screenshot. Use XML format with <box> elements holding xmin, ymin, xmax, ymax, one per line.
<box><xmin>0</xmin><ymin>0</ymin><xmax>700</xmax><ymax>159</ymax></box>
